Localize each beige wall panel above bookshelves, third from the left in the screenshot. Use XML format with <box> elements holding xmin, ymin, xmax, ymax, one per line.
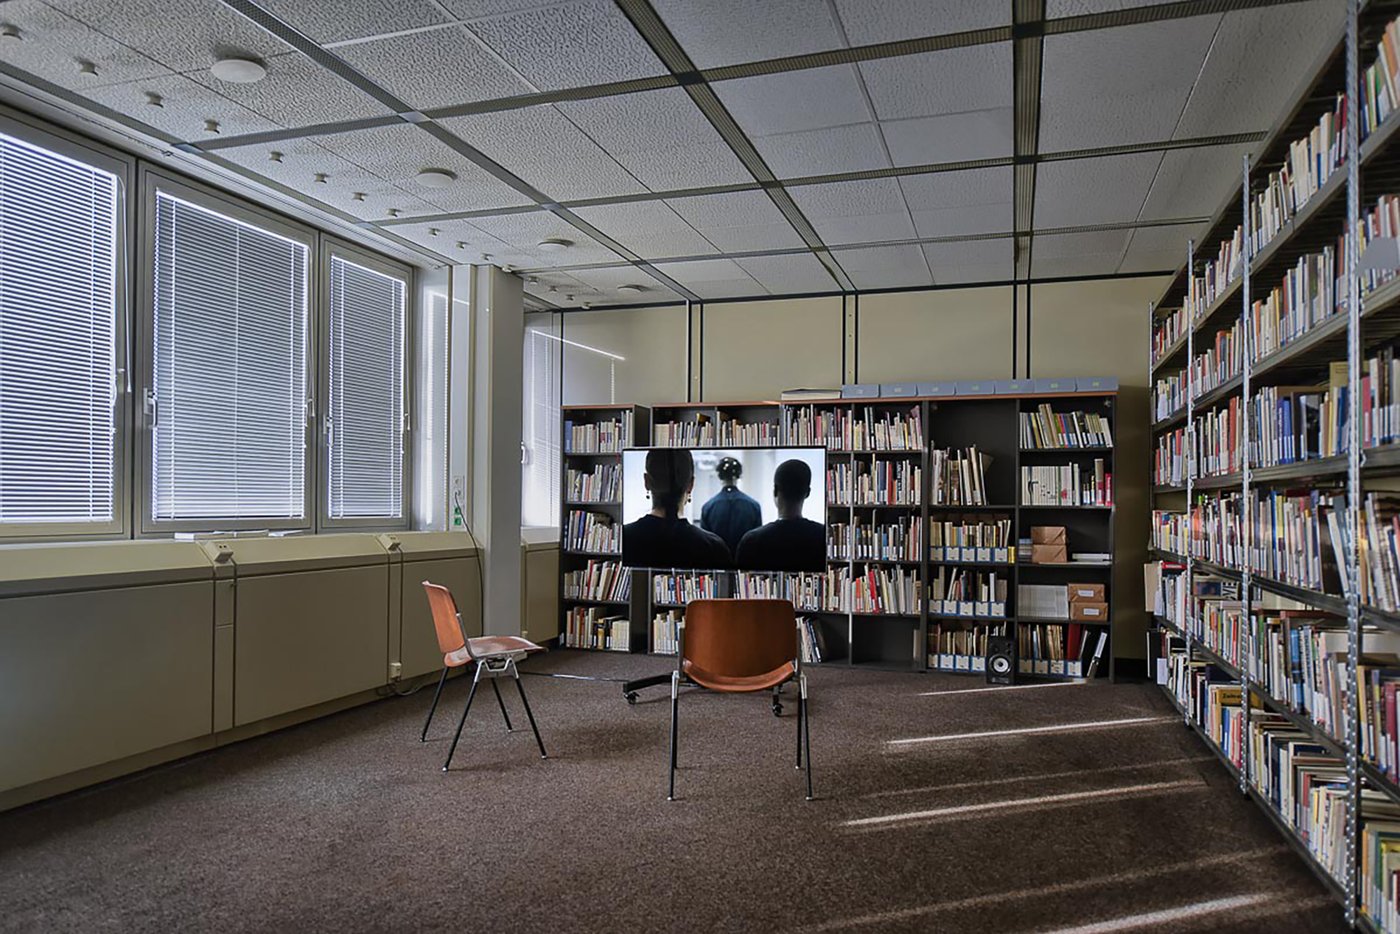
<box><xmin>855</xmin><ymin>286</ymin><xmax>1012</xmax><ymax>382</ymax></box>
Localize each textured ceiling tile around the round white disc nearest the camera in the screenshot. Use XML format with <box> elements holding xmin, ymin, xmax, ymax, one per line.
<box><xmin>186</xmin><ymin>52</ymin><xmax>392</xmax><ymax>127</ymax></box>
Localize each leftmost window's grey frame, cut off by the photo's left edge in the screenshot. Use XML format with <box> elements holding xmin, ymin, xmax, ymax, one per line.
<box><xmin>0</xmin><ymin>108</ymin><xmax>137</xmax><ymax>543</ymax></box>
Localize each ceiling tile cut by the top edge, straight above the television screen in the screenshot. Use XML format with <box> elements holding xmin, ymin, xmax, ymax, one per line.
<box><xmin>652</xmin><ymin>0</ymin><xmax>844</xmax><ymax>69</ymax></box>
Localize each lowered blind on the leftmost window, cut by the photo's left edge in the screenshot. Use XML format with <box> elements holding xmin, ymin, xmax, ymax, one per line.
<box><xmin>0</xmin><ymin>134</ymin><xmax>118</xmax><ymax>524</ymax></box>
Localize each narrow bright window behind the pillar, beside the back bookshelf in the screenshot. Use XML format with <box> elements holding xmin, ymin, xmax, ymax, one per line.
<box><xmin>521</xmin><ymin>312</ymin><xmax>563</xmax><ymax>527</ymax></box>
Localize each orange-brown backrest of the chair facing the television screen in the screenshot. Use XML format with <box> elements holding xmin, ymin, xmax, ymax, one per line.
<box><xmin>680</xmin><ymin>599</ymin><xmax>798</xmax><ymax>678</ymax></box>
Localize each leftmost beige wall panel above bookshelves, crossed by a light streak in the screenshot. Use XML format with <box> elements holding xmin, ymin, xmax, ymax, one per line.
<box><xmin>561</xmin><ymin>305</ymin><xmax>689</xmax><ymax>405</ymax></box>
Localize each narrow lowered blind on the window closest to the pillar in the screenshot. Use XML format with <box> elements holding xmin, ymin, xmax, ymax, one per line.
<box><xmin>326</xmin><ymin>255</ymin><xmax>407</xmax><ymax>520</ymax></box>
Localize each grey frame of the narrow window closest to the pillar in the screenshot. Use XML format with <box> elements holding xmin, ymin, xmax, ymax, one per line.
<box><xmin>320</xmin><ymin>234</ymin><xmax>419</xmax><ymax>532</ymax></box>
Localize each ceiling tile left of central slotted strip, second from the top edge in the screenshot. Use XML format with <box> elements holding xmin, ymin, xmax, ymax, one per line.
<box><xmin>860</xmin><ymin>42</ymin><xmax>1011</xmax><ymax>120</ymax></box>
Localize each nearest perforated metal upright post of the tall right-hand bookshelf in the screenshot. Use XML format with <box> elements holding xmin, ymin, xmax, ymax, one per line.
<box><xmin>1341</xmin><ymin>0</ymin><xmax>1361</xmax><ymax>927</ymax></box>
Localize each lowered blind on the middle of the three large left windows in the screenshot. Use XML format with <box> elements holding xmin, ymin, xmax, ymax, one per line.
<box><xmin>147</xmin><ymin>192</ymin><xmax>309</xmax><ymax>521</ymax></box>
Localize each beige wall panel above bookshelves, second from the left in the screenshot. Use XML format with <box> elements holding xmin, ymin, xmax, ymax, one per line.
<box><xmin>700</xmin><ymin>297</ymin><xmax>843</xmax><ymax>402</ymax></box>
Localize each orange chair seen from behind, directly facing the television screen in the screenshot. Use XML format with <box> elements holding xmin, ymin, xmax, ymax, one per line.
<box><xmin>666</xmin><ymin>599</ymin><xmax>812</xmax><ymax>801</ymax></box>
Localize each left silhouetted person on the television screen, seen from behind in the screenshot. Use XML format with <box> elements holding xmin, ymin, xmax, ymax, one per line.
<box><xmin>622</xmin><ymin>448</ymin><xmax>732</xmax><ymax>570</ymax></box>
